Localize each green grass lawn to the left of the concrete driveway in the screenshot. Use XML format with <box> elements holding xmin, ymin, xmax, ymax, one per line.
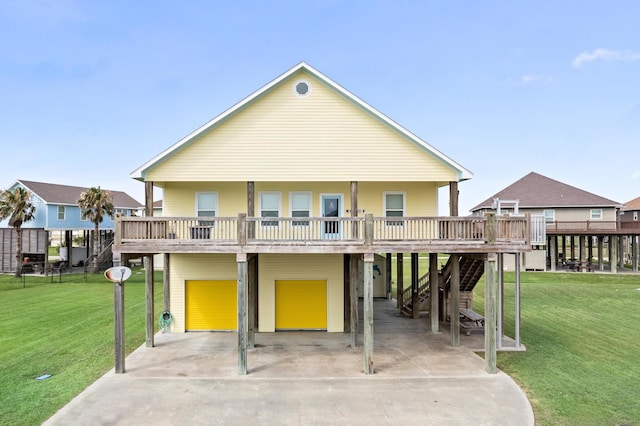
<box><xmin>0</xmin><ymin>268</ymin><xmax>162</xmax><ymax>425</ymax></box>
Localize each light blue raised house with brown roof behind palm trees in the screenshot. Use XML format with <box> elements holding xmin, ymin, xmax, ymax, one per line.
<box><xmin>0</xmin><ymin>179</ymin><xmax>142</xmax><ymax>267</ymax></box>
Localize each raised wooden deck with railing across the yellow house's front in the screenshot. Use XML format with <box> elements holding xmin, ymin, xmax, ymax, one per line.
<box><xmin>113</xmin><ymin>214</ymin><xmax>532</xmax><ymax>254</ymax></box>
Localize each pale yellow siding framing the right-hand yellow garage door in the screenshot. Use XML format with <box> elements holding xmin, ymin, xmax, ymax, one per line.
<box><xmin>258</xmin><ymin>254</ymin><xmax>344</xmax><ymax>332</ymax></box>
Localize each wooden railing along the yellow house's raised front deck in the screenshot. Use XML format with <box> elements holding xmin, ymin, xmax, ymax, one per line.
<box><xmin>115</xmin><ymin>214</ymin><xmax>531</xmax><ymax>246</ymax></box>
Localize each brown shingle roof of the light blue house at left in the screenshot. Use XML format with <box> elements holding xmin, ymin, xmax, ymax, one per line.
<box><xmin>11</xmin><ymin>179</ymin><xmax>142</xmax><ymax>209</ymax></box>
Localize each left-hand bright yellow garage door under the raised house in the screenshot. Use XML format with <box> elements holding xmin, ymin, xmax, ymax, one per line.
<box><xmin>185</xmin><ymin>280</ymin><xmax>238</xmax><ymax>331</ymax></box>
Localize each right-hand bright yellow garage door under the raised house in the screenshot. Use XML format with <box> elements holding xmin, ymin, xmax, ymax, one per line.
<box><xmin>276</xmin><ymin>280</ymin><xmax>327</xmax><ymax>330</ymax></box>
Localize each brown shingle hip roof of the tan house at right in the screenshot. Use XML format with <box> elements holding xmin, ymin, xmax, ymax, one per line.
<box><xmin>471</xmin><ymin>172</ymin><xmax>620</xmax><ymax>212</ymax></box>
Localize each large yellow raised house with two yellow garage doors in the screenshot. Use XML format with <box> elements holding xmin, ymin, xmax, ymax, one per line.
<box><xmin>113</xmin><ymin>63</ymin><xmax>530</xmax><ymax>371</ymax></box>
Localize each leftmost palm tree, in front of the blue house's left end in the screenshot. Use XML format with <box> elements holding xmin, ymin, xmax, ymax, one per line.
<box><xmin>0</xmin><ymin>187</ymin><xmax>36</xmax><ymax>278</ymax></box>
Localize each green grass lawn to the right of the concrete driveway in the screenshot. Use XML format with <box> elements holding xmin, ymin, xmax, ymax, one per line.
<box><xmin>474</xmin><ymin>272</ymin><xmax>640</xmax><ymax>426</ymax></box>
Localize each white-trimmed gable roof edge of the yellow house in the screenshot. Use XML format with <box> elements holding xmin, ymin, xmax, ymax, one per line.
<box><xmin>130</xmin><ymin>62</ymin><xmax>473</xmax><ymax>181</ymax></box>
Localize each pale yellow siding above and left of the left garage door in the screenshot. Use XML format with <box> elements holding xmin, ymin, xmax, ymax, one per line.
<box><xmin>169</xmin><ymin>254</ymin><xmax>238</xmax><ymax>332</ymax></box>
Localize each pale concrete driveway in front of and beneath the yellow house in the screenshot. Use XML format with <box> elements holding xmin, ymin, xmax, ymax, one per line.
<box><xmin>45</xmin><ymin>300</ymin><xmax>534</xmax><ymax>425</ymax></box>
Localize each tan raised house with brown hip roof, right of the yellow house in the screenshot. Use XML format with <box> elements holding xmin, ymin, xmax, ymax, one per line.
<box><xmin>471</xmin><ymin>172</ymin><xmax>627</xmax><ymax>272</ymax></box>
